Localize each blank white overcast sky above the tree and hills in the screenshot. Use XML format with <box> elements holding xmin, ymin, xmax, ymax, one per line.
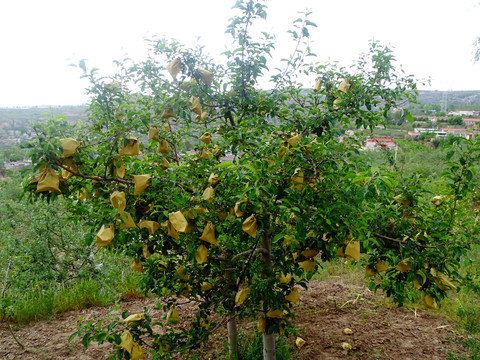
<box><xmin>0</xmin><ymin>0</ymin><xmax>480</xmax><ymax>106</ymax></box>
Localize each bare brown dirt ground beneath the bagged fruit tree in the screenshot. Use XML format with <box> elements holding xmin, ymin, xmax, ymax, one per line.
<box><xmin>0</xmin><ymin>280</ymin><xmax>462</xmax><ymax>360</ymax></box>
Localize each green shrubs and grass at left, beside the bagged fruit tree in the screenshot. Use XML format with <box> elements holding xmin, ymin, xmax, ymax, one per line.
<box><xmin>0</xmin><ymin>171</ymin><xmax>141</xmax><ymax>322</ymax></box>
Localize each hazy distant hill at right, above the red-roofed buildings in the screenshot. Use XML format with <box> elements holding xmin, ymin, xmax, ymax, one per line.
<box><xmin>417</xmin><ymin>90</ymin><xmax>480</xmax><ymax>110</ymax></box>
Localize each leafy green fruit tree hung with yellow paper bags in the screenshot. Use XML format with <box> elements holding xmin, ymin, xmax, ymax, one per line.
<box><xmin>19</xmin><ymin>0</ymin><xmax>480</xmax><ymax>359</ymax></box>
